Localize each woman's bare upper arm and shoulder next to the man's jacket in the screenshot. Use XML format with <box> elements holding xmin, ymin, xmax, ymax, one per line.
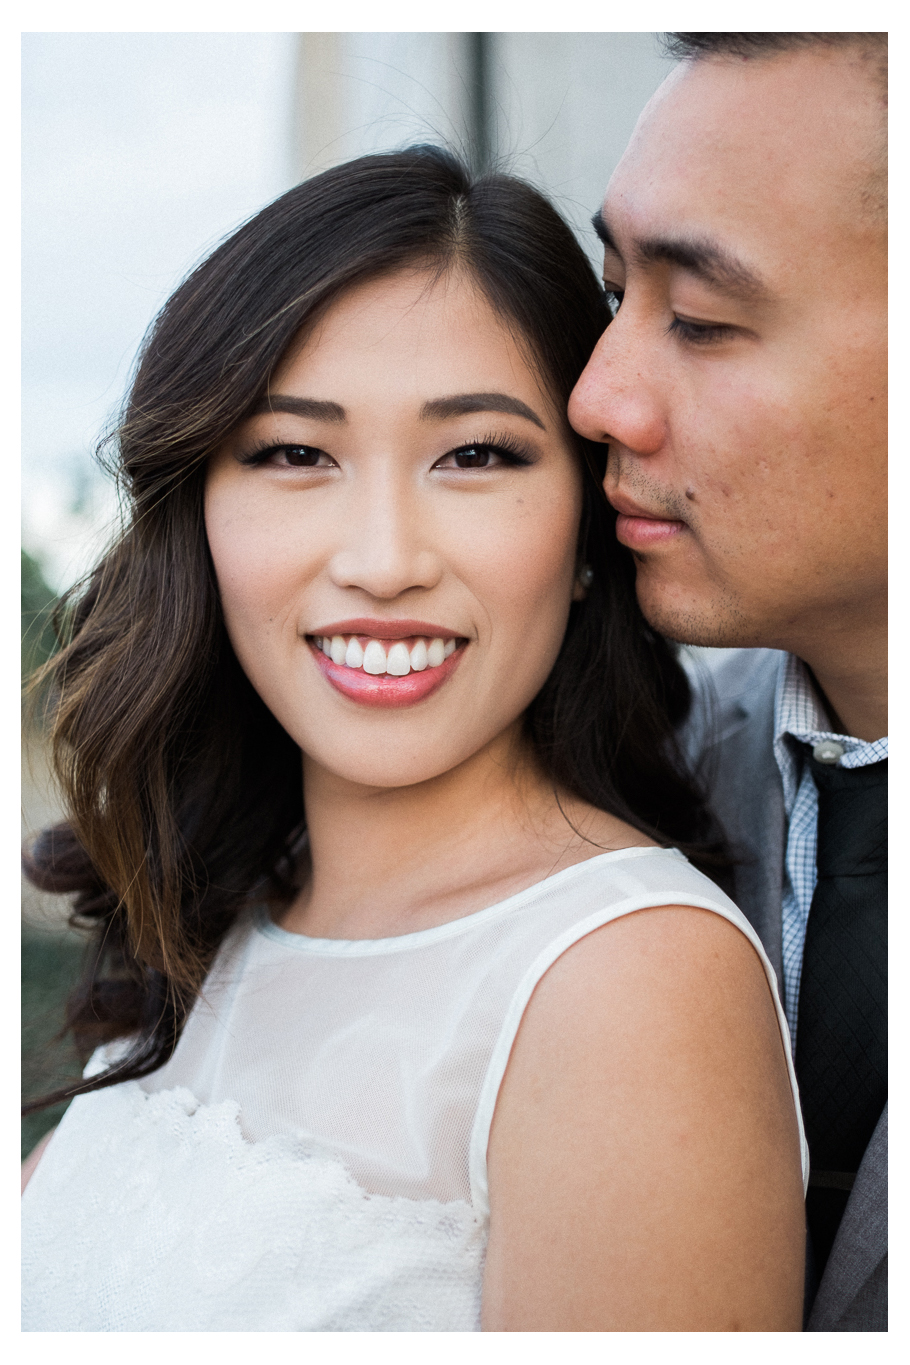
<box><xmin>484</xmin><ymin>904</ymin><xmax>802</xmax><ymax>1331</ymax></box>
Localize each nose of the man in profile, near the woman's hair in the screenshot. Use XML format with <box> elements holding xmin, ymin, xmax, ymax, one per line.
<box><xmin>569</xmin><ymin>319</ymin><xmax>666</xmax><ymax>455</ymax></box>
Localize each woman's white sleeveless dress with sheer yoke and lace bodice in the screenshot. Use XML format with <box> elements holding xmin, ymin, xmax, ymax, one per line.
<box><xmin>23</xmin><ymin>848</ymin><xmax>808</xmax><ymax>1332</ymax></box>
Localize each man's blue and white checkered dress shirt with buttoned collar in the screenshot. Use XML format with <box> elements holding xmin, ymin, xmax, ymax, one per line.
<box><xmin>774</xmin><ymin>654</ymin><xmax>888</xmax><ymax>1057</ymax></box>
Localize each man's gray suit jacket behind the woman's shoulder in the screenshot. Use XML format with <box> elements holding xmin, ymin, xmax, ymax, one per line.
<box><xmin>684</xmin><ymin>650</ymin><xmax>888</xmax><ymax>1332</ymax></box>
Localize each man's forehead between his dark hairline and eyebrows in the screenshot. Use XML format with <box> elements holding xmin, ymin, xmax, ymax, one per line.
<box><xmin>602</xmin><ymin>52</ymin><xmax>880</xmax><ymax>279</ymax></box>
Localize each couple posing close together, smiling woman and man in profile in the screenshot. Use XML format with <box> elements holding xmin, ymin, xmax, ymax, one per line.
<box><xmin>23</xmin><ymin>34</ymin><xmax>887</xmax><ymax>1331</ymax></box>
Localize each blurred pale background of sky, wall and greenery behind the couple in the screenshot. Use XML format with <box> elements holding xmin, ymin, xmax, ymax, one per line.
<box><xmin>22</xmin><ymin>33</ymin><xmax>670</xmax><ymax>1151</ymax></box>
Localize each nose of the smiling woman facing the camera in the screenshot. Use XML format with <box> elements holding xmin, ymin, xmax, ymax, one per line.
<box><xmin>329</xmin><ymin>479</ymin><xmax>442</xmax><ymax>599</ymax></box>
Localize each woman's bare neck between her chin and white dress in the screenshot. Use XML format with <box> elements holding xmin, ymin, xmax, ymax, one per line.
<box><xmin>281</xmin><ymin>725</ymin><xmax>648</xmax><ymax>939</ymax></box>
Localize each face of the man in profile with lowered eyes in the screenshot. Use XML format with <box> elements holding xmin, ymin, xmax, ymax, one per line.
<box><xmin>569</xmin><ymin>49</ymin><xmax>887</xmax><ymax>657</ymax></box>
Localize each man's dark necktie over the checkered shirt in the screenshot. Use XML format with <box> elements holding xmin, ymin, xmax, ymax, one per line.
<box><xmin>795</xmin><ymin>747</ymin><xmax>888</xmax><ymax>1278</ymax></box>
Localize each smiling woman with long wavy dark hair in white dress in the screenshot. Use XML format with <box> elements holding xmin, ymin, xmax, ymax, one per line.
<box><xmin>25</xmin><ymin>149</ymin><xmax>802</xmax><ymax>1331</ymax></box>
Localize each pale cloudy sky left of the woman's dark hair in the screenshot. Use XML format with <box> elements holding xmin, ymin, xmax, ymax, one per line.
<box><xmin>22</xmin><ymin>33</ymin><xmax>297</xmax><ymax>588</ymax></box>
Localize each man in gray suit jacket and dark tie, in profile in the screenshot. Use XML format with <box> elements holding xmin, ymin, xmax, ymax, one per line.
<box><xmin>569</xmin><ymin>33</ymin><xmax>888</xmax><ymax>1331</ymax></box>
